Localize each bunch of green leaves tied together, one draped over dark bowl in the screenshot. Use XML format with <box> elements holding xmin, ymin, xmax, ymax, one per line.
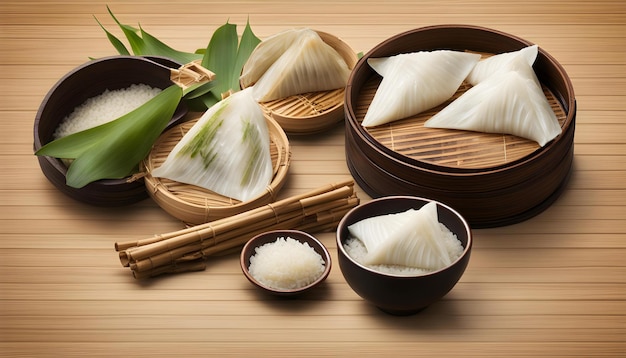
<box><xmin>35</xmin><ymin>6</ymin><xmax>260</xmax><ymax>188</ymax></box>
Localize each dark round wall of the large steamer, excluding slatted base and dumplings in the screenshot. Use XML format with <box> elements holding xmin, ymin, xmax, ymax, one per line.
<box><xmin>345</xmin><ymin>25</ymin><xmax>576</xmax><ymax>227</ymax></box>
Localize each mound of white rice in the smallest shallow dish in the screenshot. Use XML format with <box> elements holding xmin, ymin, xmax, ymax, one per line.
<box><xmin>248</xmin><ymin>237</ymin><xmax>325</xmax><ymax>289</ymax></box>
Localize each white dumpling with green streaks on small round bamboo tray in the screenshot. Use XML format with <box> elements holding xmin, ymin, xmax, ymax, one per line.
<box><xmin>152</xmin><ymin>88</ymin><xmax>273</xmax><ymax>201</ymax></box>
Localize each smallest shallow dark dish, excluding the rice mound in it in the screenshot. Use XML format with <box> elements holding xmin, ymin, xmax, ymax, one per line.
<box><xmin>239</xmin><ymin>230</ymin><xmax>331</xmax><ymax>296</ymax></box>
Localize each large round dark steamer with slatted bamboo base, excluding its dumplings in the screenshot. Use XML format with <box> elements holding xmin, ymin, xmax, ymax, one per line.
<box><xmin>345</xmin><ymin>25</ymin><xmax>576</xmax><ymax>227</ymax></box>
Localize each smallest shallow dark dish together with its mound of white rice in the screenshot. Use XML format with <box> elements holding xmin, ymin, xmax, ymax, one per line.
<box><xmin>240</xmin><ymin>230</ymin><xmax>331</xmax><ymax>296</ymax></box>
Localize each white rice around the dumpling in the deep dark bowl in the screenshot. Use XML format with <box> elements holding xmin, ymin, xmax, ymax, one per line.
<box><xmin>343</xmin><ymin>223</ymin><xmax>464</xmax><ymax>276</ymax></box>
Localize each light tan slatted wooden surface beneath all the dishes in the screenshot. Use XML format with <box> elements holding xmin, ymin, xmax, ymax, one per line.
<box><xmin>0</xmin><ymin>0</ymin><xmax>626</xmax><ymax>357</ymax></box>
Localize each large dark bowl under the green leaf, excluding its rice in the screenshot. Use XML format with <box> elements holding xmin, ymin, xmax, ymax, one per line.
<box><xmin>34</xmin><ymin>56</ymin><xmax>187</xmax><ymax>206</ymax></box>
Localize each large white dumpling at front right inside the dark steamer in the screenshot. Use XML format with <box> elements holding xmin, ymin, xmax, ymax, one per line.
<box><xmin>424</xmin><ymin>70</ymin><xmax>561</xmax><ymax>147</ymax></box>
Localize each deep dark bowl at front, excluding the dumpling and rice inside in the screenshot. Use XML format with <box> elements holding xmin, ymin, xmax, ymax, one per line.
<box><xmin>337</xmin><ymin>196</ymin><xmax>472</xmax><ymax>315</ymax></box>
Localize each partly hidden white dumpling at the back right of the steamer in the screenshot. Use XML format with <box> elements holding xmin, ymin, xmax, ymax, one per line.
<box><xmin>466</xmin><ymin>45</ymin><xmax>539</xmax><ymax>86</ymax></box>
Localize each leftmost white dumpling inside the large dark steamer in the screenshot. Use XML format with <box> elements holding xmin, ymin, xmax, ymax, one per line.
<box><xmin>361</xmin><ymin>50</ymin><xmax>480</xmax><ymax>127</ymax></box>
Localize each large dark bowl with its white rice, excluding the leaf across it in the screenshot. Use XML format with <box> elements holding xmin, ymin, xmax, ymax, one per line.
<box><xmin>33</xmin><ymin>56</ymin><xmax>187</xmax><ymax>206</ymax></box>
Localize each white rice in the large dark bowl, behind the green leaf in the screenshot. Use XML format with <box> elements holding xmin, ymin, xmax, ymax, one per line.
<box><xmin>53</xmin><ymin>84</ymin><xmax>161</xmax><ymax>139</ymax></box>
